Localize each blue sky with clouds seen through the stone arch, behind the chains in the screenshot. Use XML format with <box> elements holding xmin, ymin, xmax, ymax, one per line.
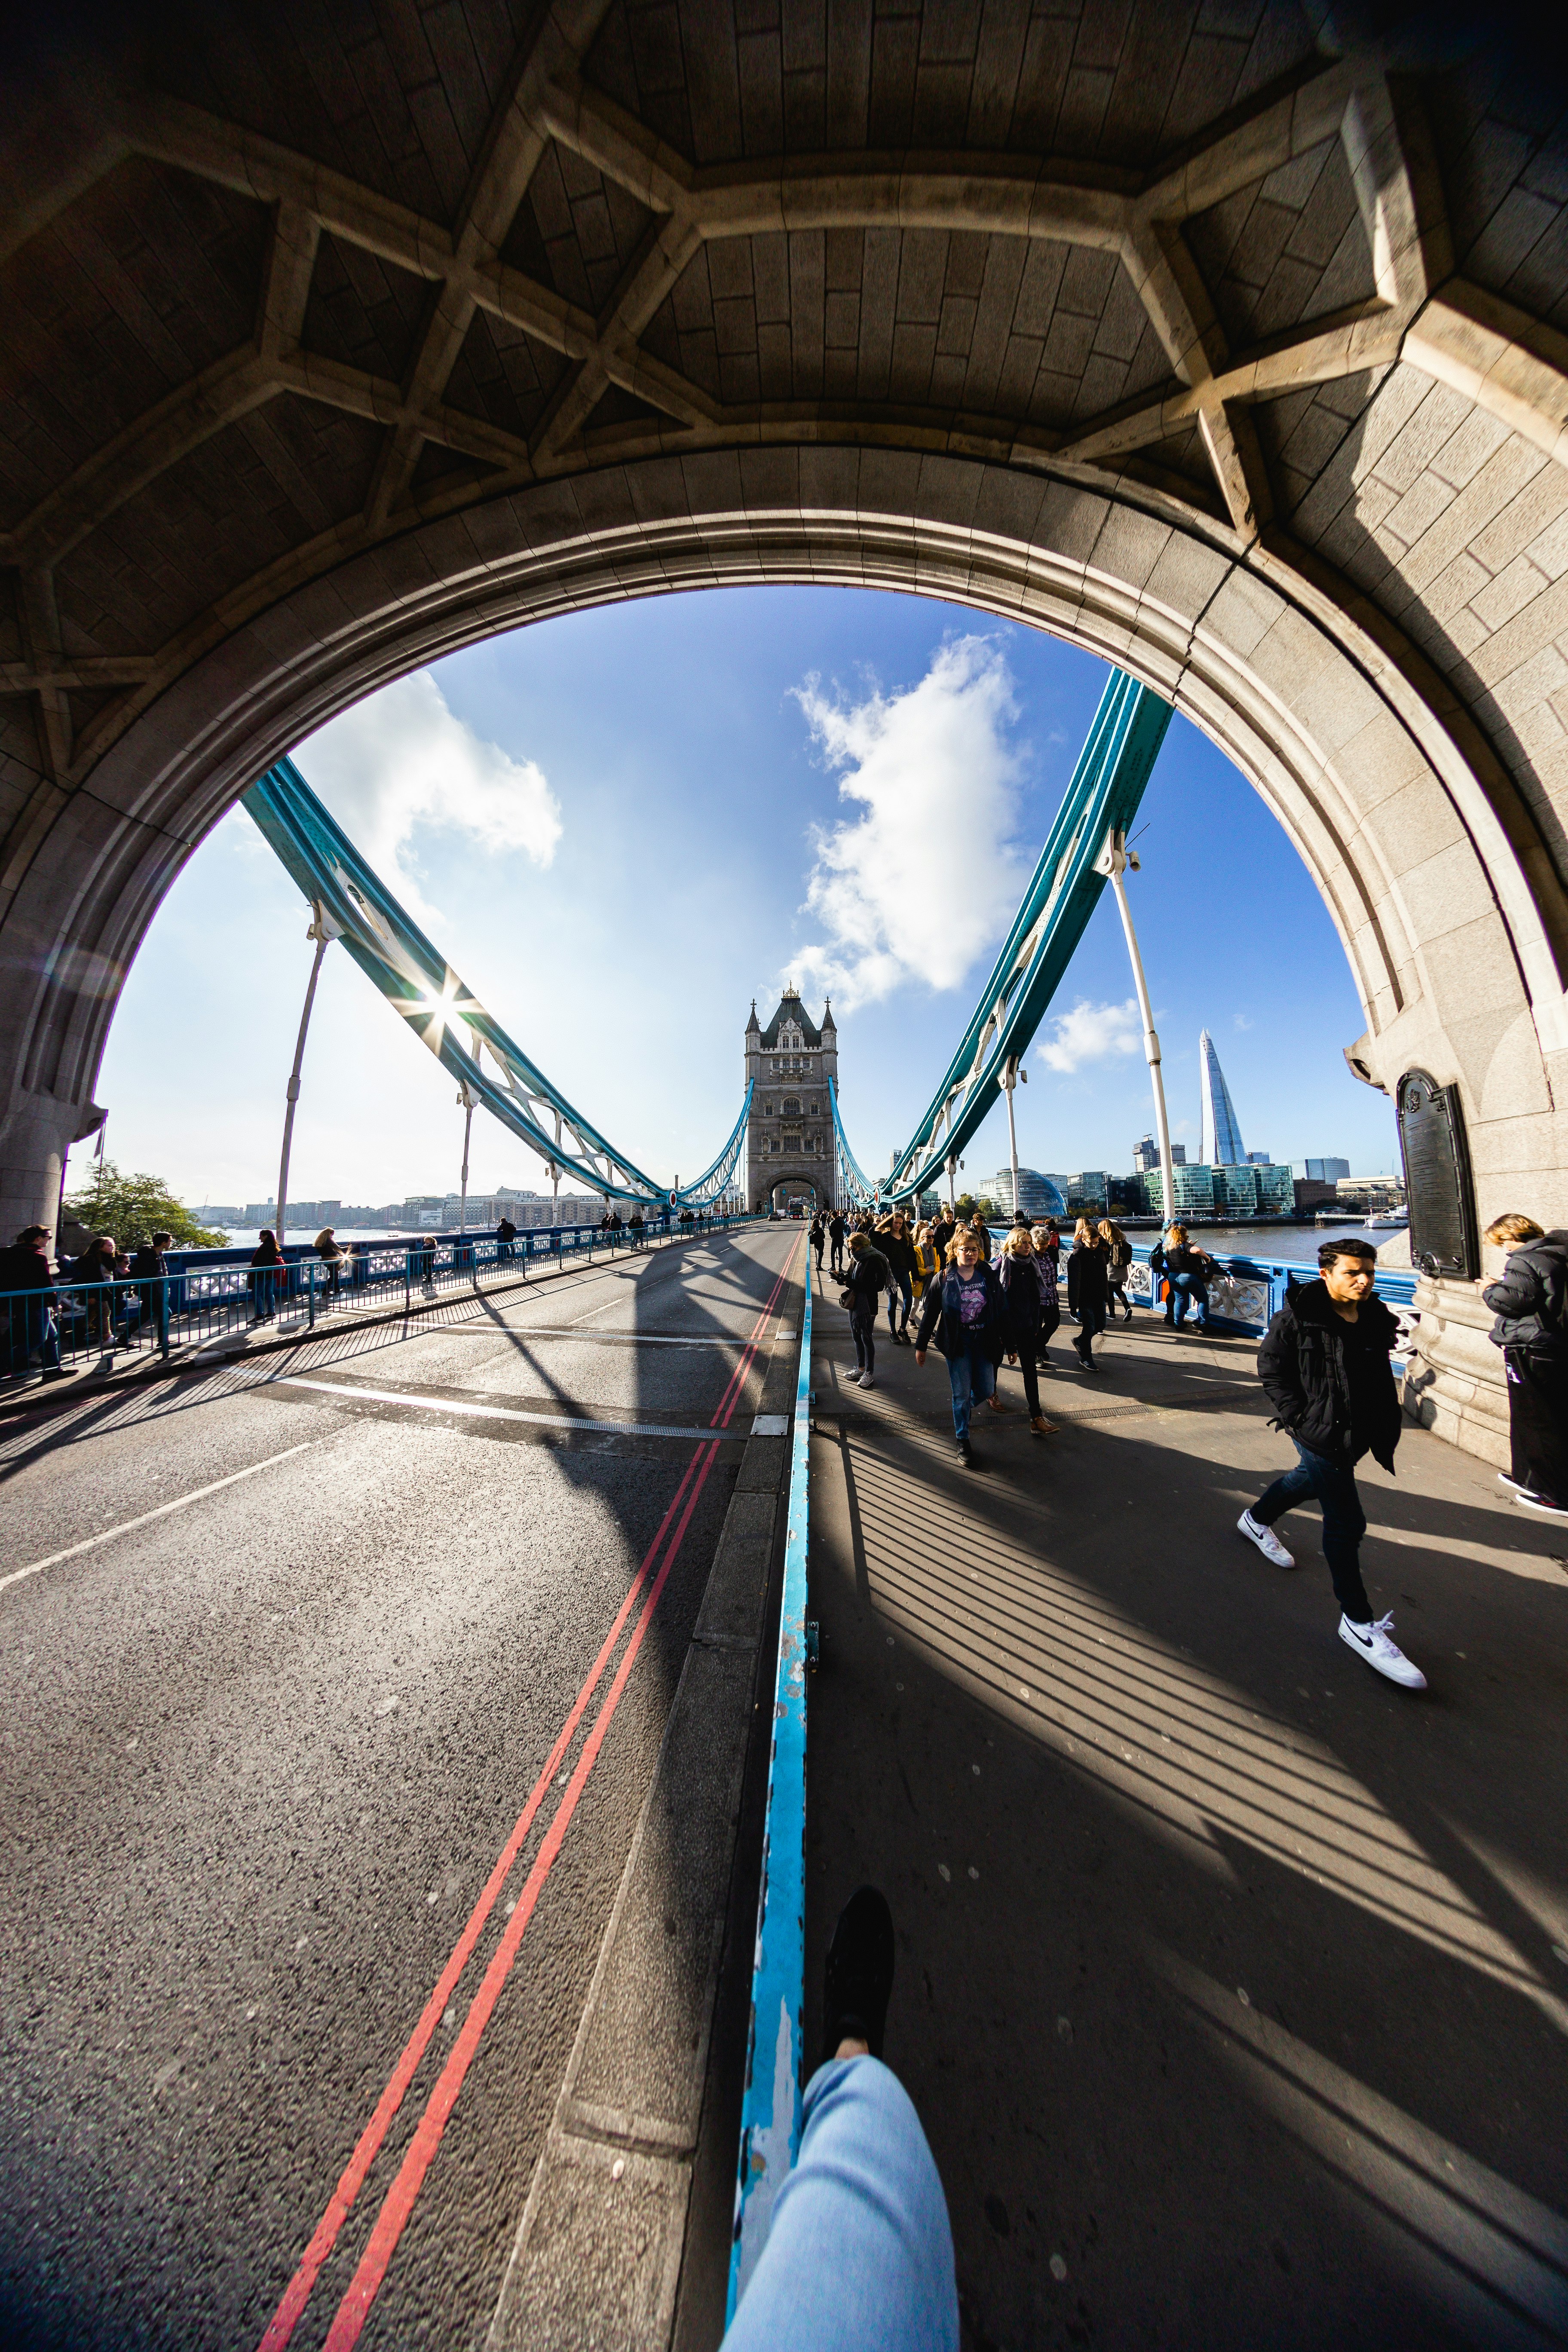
<box><xmin>96</xmin><ymin>588</ymin><xmax>1394</xmax><ymax>1202</ymax></box>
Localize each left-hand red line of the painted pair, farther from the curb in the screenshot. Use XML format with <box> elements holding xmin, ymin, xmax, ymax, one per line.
<box><xmin>259</xmin><ymin>1240</ymin><xmax>799</xmax><ymax>2352</ymax></box>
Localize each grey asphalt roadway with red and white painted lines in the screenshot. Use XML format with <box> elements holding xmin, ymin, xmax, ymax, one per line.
<box><xmin>0</xmin><ymin>1228</ymin><xmax>797</xmax><ymax>2352</ymax></box>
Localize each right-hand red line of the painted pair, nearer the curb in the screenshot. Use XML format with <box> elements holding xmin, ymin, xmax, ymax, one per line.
<box><xmin>325</xmin><ymin>1439</ymin><xmax>720</xmax><ymax>2352</ymax></box>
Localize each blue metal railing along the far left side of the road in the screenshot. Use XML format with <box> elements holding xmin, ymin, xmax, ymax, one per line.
<box><xmin>0</xmin><ymin>1214</ymin><xmax>755</xmax><ymax>1385</ymax></box>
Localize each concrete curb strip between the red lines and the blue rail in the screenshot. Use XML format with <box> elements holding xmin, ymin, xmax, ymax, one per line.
<box><xmin>487</xmin><ymin>1277</ymin><xmax>802</xmax><ymax>2352</ymax></box>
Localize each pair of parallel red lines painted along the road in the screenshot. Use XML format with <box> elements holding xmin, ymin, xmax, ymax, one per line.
<box><xmin>259</xmin><ymin>1244</ymin><xmax>799</xmax><ymax>2352</ymax></box>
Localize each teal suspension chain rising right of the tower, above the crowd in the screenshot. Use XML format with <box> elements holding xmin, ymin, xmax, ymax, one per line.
<box><xmin>832</xmin><ymin>671</ymin><xmax>1171</xmax><ymax>1202</ymax></box>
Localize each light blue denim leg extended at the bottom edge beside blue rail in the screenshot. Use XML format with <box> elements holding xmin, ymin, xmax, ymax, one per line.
<box><xmin>724</xmin><ymin>2058</ymin><xmax>959</xmax><ymax>2352</ymax></box>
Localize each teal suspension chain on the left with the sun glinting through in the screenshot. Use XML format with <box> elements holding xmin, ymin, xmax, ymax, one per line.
<box><xmin>242</xmin><ymin>760</ymin><xmax>752</xmax><ymax>1207</ymax></box>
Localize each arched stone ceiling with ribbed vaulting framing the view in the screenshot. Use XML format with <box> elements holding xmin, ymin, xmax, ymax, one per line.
<box><xmin>0</xmin><ymin>0</ymin><xmax>1568</xmax><ymax>1270</ymax></box>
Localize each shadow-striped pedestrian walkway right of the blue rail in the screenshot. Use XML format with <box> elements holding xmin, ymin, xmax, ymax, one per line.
<box><xmin>806</xmin><ymin>1284</ymin><xmax>1568</xmax><ymax>2352</ymax></box>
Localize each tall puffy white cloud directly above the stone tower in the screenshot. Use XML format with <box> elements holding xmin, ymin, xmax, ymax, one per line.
<box><xmin>790</xmin><ymin>637</ymin><xmax>1020</xmax><ymax>1009</ymax></box>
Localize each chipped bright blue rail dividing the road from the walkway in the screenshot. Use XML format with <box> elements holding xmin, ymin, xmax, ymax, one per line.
<box><xmin>724</xmin><ymin>1261</ymin><xmax>811</xmax><ymax>2326</ymax></box>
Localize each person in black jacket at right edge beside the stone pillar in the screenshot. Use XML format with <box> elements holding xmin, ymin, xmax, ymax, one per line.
<box><xmin>1481</xmin><ymin>1214</ymin><xmax>1568</xmax><ymax>1519</ymax></box>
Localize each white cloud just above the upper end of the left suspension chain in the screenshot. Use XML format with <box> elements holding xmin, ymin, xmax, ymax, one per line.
<box><xmin>299</xmin><ymin>671</ymin><xmax>562</xmax><ymax>920</ymax></box>
